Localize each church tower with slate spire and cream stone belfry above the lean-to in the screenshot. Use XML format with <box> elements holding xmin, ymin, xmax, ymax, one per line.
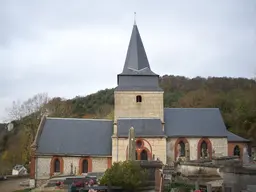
<box><xmin>114</xmin><ymin>23</ymin><xmax>164</xmax><ymax>135</ymax></box>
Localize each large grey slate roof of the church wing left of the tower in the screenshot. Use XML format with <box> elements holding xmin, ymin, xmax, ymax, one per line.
<box><xmin>36</xmin><ymin>118</ymin><xmax>113</xmax><ymax>156</ymax></box>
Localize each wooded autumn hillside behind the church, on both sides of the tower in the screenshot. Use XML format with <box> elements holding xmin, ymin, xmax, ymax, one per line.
<box><xmin>0</xmin><ymin>75</ymin><xmax>256</xmax><ymax>171</ymax></box>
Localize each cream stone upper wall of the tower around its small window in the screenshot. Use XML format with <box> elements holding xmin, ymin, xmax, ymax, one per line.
<box><xmin>114</xmin><ymin>91</ymin><xmax>164</xmax><ymax>134</ymax></box>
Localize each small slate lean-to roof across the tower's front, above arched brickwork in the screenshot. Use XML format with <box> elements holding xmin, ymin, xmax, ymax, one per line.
<box><xmin>117</xmin><ymin>118</ymin><xmax>165</xmax><ymax>137</ymax></box>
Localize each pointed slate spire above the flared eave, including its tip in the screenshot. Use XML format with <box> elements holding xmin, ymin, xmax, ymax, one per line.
<box><xmin>122</xmin><ymin>22</ymin><xmax>156</xmax><ymax>75</ymax></box>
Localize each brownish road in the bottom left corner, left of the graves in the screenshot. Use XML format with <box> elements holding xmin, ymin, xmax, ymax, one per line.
<box><xmin>0</xmin><ymin>178</ymin><xmax>28</xmax><ymax>192</ymax></box>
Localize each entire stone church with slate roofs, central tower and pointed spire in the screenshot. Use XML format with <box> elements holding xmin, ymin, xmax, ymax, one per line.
<box><xmin>30</xmin><ymin>24</ymin><xmax>249</xmax><ymax>186</ymax></box>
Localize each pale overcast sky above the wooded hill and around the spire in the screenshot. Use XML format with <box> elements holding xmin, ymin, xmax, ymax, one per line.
<box><xmin>0</xmin><ymin>0</ymin><xmax>256</xmax><ymax>121</ymax></box>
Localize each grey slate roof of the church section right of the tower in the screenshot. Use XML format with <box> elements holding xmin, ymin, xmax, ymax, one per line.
<box><xmin>164</xmin><ymin>108</ymin><xmax>227</xmax><ymax>137</ymax></box>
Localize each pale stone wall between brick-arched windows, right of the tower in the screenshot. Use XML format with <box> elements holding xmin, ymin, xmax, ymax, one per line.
<box><xmin>167</xmin><ymin>138</ymin><xmax>228</xmax><ymax>163</ymax></box>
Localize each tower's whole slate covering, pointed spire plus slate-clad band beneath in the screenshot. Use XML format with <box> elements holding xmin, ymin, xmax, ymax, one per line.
<box><xmin>115</xmin><ymin>25</ymin><xmax>163</xmax><ymax>91</ymax></box>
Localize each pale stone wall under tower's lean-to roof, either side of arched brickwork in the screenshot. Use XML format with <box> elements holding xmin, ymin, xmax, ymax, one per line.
<box><xmin>112</xmin><ymin>137</ymin><xmax>166</xmax><ymax>163</ymax></box>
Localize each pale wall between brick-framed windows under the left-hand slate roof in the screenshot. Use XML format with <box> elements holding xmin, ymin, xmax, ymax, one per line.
<box><xmin>35</xmin><ymin>156</ymin><xmax>109</xmax><ymax>180</ymax></box>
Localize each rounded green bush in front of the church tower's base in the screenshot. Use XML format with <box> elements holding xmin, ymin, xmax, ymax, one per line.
<box><xmin>100</xmin><ymin>161</ymin><xmax>148</xmax><ymax>191</ymax></box>
